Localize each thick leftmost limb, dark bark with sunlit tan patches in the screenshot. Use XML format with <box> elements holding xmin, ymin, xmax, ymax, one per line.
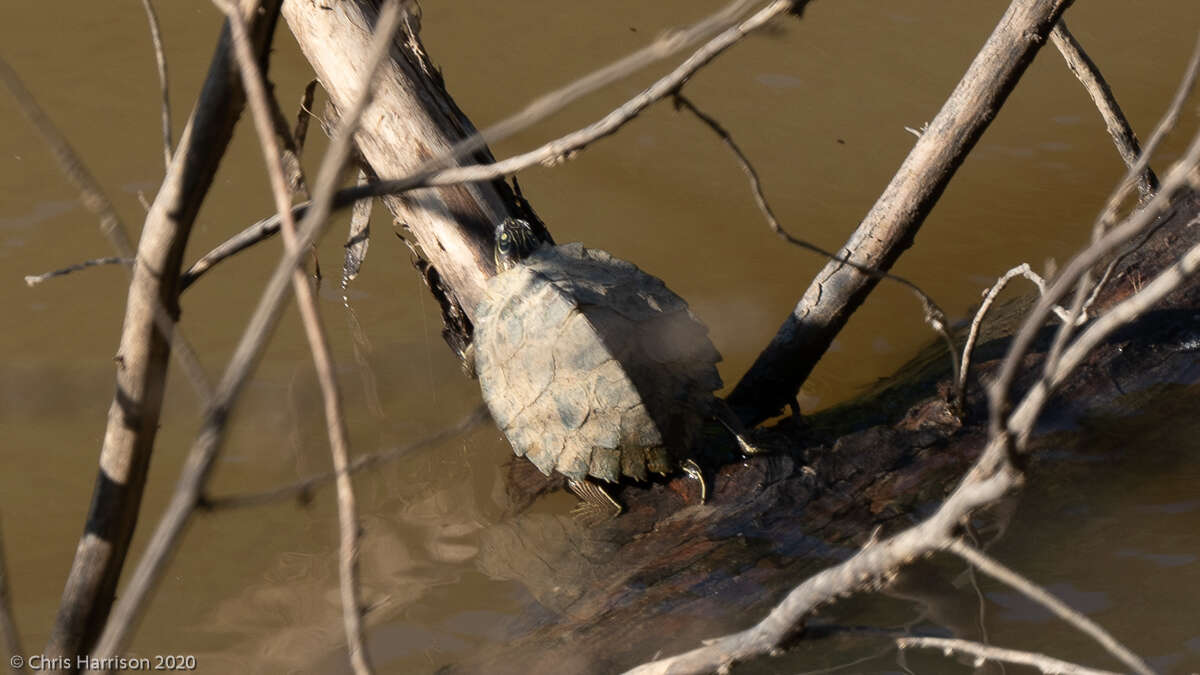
<box><xmin>38</xmin><ymin>0</ymin><xmax>278</xmax><ymax>656</ymax></box>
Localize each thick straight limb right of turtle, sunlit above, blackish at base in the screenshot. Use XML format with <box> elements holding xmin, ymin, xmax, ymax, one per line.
<box><xmin>728</xmin><ymin>0</ymin><xmax>1070</xmax><ymax>424</ymax></box>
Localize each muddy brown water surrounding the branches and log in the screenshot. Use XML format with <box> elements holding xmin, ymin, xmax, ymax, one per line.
<box><xmin>0</xmin><ymin>0</ymin><xmax>1200</xmax><ymax>673</ymax></box>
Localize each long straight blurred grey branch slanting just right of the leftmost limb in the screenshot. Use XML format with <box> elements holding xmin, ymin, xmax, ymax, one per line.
<box><xmin>83</xmin><ymin>3</ymin><xmax>403</xmax><ymax>658</ymax></box>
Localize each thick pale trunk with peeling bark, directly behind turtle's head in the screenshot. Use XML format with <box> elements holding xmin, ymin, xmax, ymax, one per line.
<box><xmin>283</xmin><ymin>0</ymin><xmax>526</xmax><ymax>330</ymax></box>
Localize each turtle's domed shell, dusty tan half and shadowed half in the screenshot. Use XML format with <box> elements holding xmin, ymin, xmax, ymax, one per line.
<box><xmin>475</xmin><ymin>244</ymin><xmax>721</xmax><ymax>482</ymax></box>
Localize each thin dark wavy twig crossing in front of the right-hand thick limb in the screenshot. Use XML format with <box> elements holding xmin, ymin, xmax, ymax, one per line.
<box><xmin>674</xmin><ymin>91</ymin><xmax>960</xmax><ymax>396</ymax></box>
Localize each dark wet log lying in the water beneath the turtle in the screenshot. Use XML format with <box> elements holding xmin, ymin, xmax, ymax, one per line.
<box><xmin>445</xmin><ymin>192</ymin><xmax>1200</xmax><ymax>673</ymax></box>
